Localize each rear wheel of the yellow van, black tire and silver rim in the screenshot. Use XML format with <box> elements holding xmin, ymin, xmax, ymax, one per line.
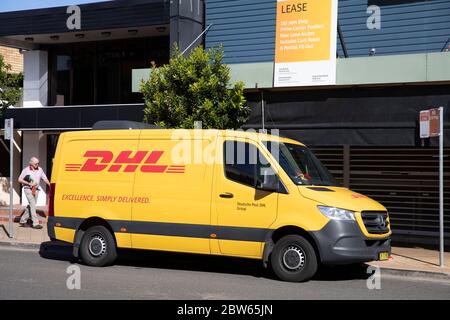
<box><xmin>80</xmin><ymin>226</ymin><xmax>117</xmax><ymax>267</ymax></box>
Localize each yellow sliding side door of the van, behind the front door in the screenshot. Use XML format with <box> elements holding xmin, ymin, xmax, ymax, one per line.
<box><xmin>132</xmin><ymin>130</ymin><xmax>215</xmax><ymax>253</ymax></box>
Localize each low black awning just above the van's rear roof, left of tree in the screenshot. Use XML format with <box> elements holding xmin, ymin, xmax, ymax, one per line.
<box><xmin>5</xmin><ymin>104</ymin><xmax>144</xmax><ymax>130</ymax></box>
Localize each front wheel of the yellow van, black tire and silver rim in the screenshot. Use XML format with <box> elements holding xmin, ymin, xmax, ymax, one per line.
<box><xmin>270</xmin><ymin>235</ymin><xmax>318</xmax><ymax>282</ymax></box>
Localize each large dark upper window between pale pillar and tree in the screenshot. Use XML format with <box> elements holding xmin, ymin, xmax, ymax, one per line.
<box><xmin>45</xmin><ymin>36</ymin><xmax>170</xmax><ymax>106</ymax></box>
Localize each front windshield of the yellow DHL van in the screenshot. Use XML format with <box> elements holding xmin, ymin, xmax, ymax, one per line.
<box><xmin>263</xmin><ymin>141</ymin><xmax>339</xmax><ymax>186</ymax></box>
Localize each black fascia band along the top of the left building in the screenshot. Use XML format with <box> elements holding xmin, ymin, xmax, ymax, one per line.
<box><xmin>0</xmin><ymin>0</ymin><xmax>170</xmax><ymax>36</ymax></box>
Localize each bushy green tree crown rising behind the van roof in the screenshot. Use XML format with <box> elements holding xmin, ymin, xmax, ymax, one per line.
<box><xmin>141</xmin><ymin>47</ymin><xmax>249</xmax><ymax>129</ymax></box>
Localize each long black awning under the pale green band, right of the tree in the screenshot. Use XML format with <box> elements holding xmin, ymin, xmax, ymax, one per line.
<box><xmin>243</xmin><ymin>86</ymin><xmax>450</xmax><ymax>146</ymax></box>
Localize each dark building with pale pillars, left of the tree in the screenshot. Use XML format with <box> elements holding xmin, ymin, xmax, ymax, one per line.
<box><xmin>0</xmin><ymin>0</ymin><xmax>204</xmax><ymax>205</ymax></box>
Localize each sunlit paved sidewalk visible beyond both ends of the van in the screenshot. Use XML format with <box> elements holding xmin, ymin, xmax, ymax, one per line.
<box><xmin>0</xmin><ymin>206</ymin><xmax>450</xmax><ymax>280</ymax></box>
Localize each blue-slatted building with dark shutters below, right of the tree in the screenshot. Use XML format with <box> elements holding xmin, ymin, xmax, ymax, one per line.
<box><xmin>206</xmin><ymin>0</ymin><xmax>450</xmax><ymax>248</ymax></box>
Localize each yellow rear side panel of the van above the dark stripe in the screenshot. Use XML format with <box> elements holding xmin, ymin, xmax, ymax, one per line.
<box><xmin>52</xmin><ymin>130</ymin><xmax>139</xmax><ymax>225</ymax></box>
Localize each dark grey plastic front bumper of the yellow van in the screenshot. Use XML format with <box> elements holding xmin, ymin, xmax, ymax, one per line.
<box><xmin>311</xmin><ymin>220</ymin><xmax>391</xmax><ymax>264</ymax></box>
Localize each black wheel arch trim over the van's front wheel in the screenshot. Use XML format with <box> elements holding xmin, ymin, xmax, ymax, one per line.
<box><xmin>263</xmin><ymin>226</ymin><xmax>322</xmax><ymax>268</ymax></box>
